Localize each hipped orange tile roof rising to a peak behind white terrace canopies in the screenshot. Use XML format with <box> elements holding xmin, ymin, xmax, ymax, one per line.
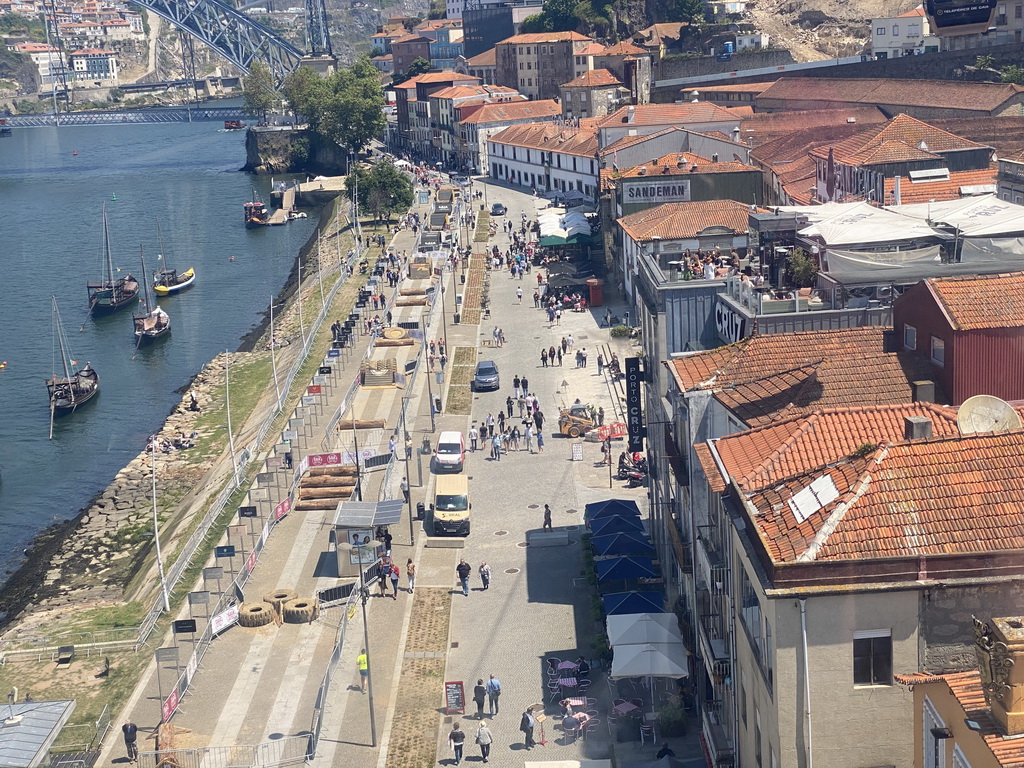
<box><xmin>811</xmin><ymin>115</ymin><xmax>983</xmax><ymax>166</ymax></box>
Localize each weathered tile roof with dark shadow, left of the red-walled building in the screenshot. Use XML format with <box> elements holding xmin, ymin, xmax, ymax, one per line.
<box><xmin>667</xmin><ymin>325</ymin><xmax>945</xmax><ymax>427</ymax></box>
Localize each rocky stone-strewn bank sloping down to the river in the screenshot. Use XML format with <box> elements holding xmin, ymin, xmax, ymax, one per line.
<box><xmin>0</xmin><ymin>196</ymin><xmax>337</xmax><ymax>641</ymax></box>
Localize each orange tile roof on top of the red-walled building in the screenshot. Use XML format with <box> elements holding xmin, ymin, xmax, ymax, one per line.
<box><xmin>925</xmin><ymin>272</ymin><xmax>1024</xmax><ymax>331</ymax></box>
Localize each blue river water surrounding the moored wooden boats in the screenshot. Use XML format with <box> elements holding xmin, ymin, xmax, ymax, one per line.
<box><xmin>0</xmin><ymin>122</ymin><xmax>315</xmax><ymax>578</ymax></box>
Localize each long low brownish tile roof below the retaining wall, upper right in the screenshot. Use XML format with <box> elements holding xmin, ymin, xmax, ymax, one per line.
<box><xmin>759</xmin><ymin>78</ymin><xmax>1024</xmax><ymax>112</ymax></box>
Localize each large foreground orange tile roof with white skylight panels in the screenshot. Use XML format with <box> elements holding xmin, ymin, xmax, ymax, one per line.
<box><xmin>748</xmin><ymin>434</ymin><xmax>1024</xmax><ymax>562</ymax></box>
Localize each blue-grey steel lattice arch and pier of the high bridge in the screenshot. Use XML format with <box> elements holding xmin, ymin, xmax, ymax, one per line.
<box><xmin>125</xmin><ymin>0</ymin><xmax>332</xmax><ymax>83</ymax></box>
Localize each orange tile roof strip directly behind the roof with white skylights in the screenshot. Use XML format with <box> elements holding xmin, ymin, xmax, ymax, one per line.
<box><xmin>698</xmin><ymin>402</ymin><xmax>959</xmax><ymax>493</ymax></box>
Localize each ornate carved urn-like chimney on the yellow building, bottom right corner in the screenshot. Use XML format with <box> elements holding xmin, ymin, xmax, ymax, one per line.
<box><xmin>974</xmin><ymin>616</ymin><xmax>1024</xmax><ymax>736</ymax></box>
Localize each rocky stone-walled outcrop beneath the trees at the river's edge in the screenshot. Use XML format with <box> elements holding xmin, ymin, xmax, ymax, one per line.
<box><xmin>242</xmin><ymin>128</ymin><xmax>348</xmax><ymax>176</ymax></box>
